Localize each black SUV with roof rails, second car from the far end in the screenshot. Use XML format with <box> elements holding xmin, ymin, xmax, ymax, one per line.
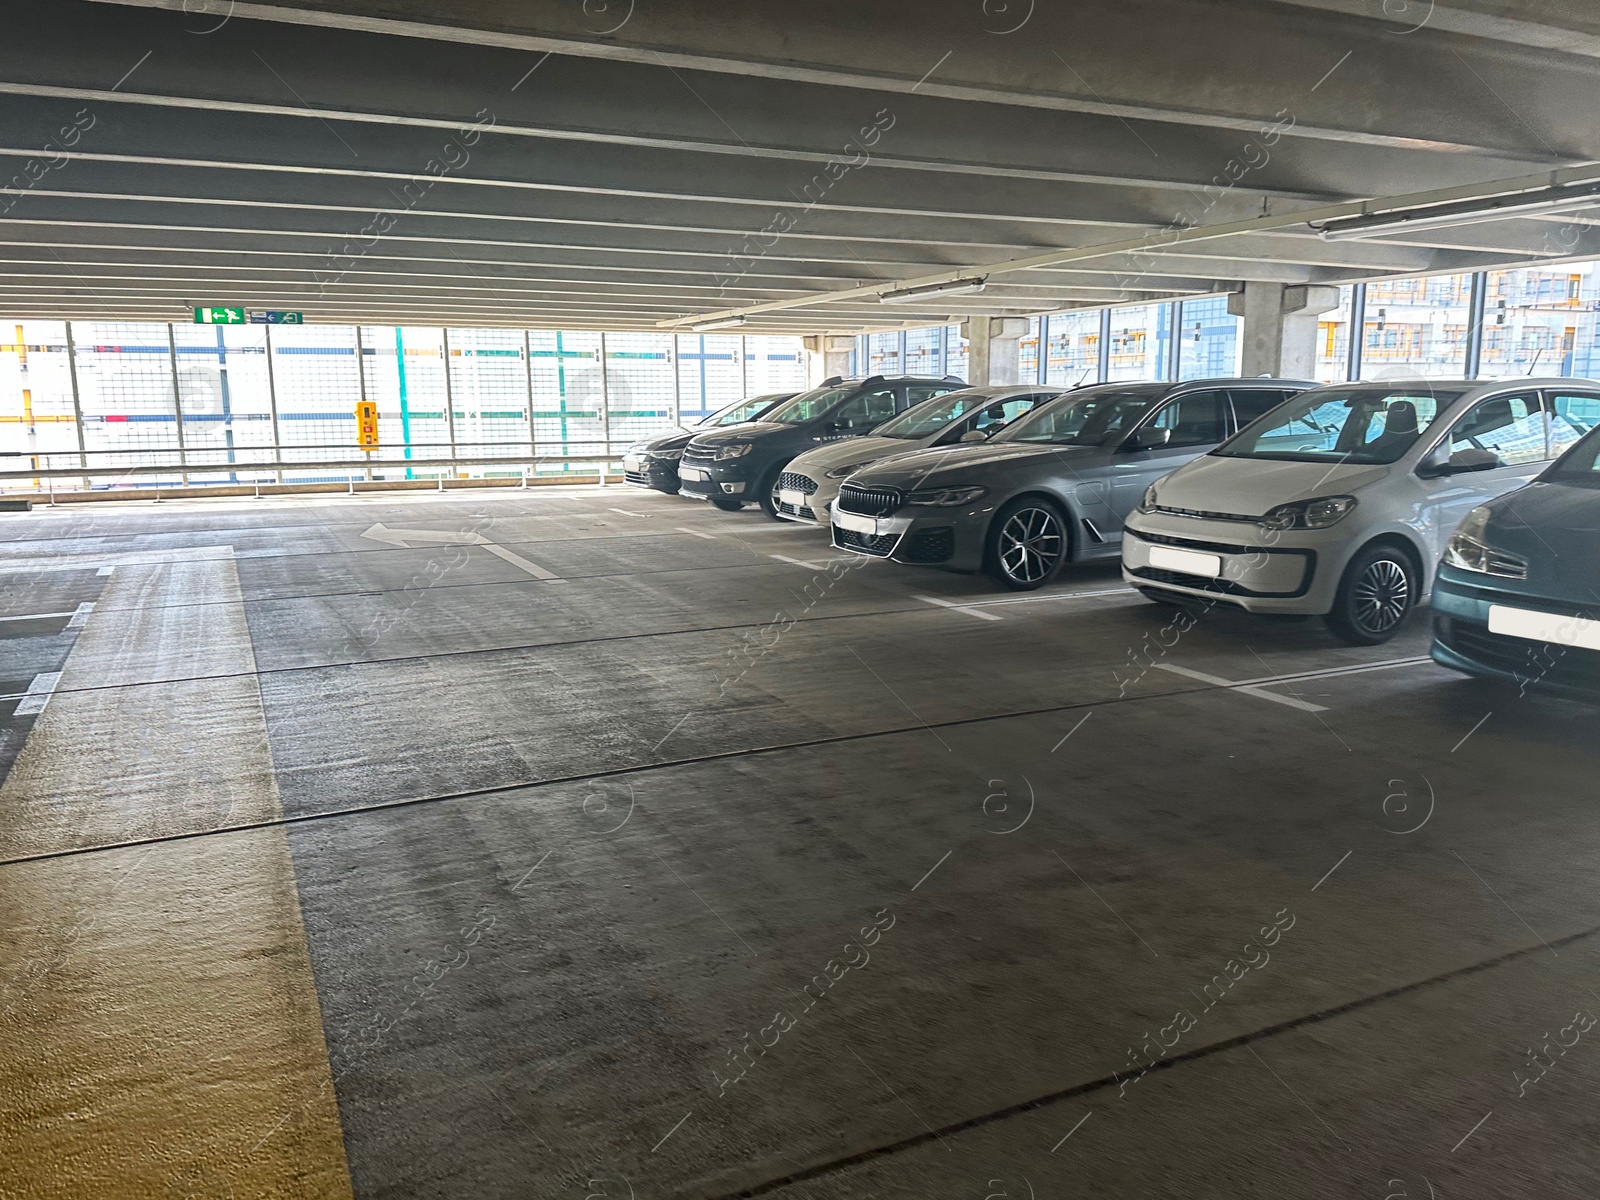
<box><xmin>678</xmin><ymin>374</ymin><xmax>966</xmax><ymax>518</ymax></box>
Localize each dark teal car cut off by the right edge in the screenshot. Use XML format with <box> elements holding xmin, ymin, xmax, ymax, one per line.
<box><xmin>1434</xmin><ymin>409</ymin><xmax>1600</xmax><ymax>701</ymax></box>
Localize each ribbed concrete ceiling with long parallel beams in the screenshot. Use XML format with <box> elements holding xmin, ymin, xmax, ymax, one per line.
<box><xmin>0</xmin><ymin>0</ymin><xmax>1600</xmax><ymax>333</ymax></box>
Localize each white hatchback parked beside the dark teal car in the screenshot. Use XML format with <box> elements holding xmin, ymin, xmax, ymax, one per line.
<box><xmin>1122</xmin><ymin>379</ymin><xmax>1600</xmax><ymax>645</ymax></box>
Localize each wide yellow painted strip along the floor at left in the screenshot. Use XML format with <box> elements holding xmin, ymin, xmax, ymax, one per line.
<box><xmin>0</xmin><ymin>549</ymin><xmax>350</xmax><ymax>1200</ymax></box>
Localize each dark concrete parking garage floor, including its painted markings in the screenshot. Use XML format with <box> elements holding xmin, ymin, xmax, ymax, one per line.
<box><xmin>0</xmin><ymin>488</ymin><xmax>1600</xmax><ymax>1200</ymax></box>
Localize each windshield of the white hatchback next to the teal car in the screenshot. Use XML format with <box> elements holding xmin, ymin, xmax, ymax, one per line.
<box><xmin>1211</xmin><ymin>384</ymin><xmax>1464</xmax><ymax>464</ymax></box>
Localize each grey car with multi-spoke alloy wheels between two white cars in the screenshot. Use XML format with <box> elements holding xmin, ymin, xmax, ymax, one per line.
<box><xmin>832</xmin><ymin>379</ymin><xmax>1317</xmax><ymax>590</ymax></box>
